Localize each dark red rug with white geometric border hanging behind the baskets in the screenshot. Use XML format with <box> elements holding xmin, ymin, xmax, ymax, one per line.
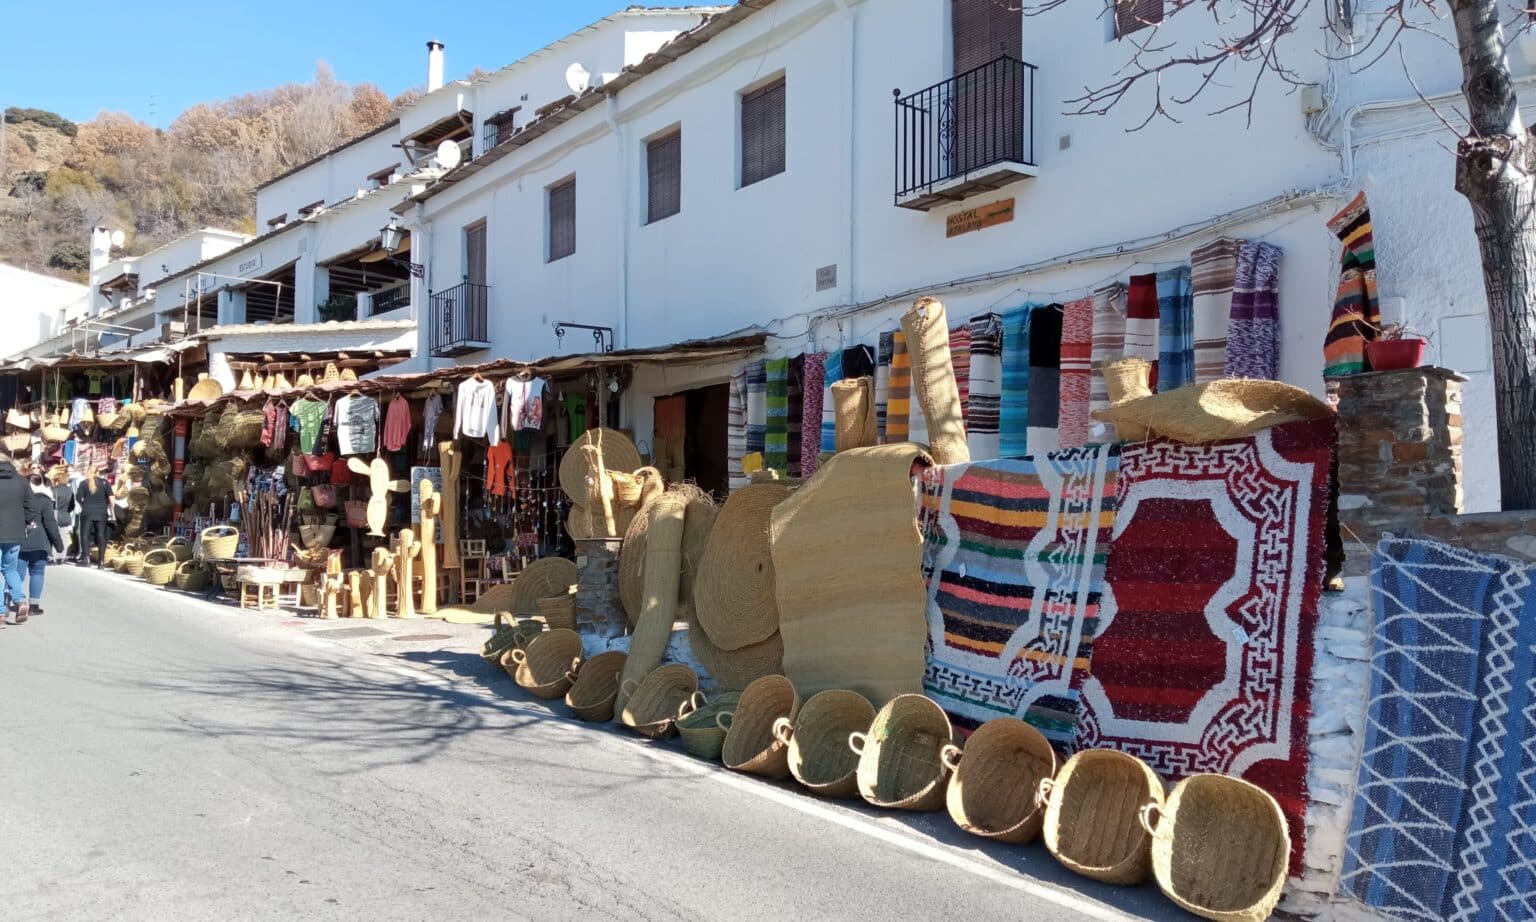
<box><xmin>1077</xmin><ymin>418</ymin><xmax>1335</xmax><ymax>873</ymax></box>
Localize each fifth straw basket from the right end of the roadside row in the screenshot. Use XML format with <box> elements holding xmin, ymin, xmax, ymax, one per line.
<box><xmin>773</xmin><ymin>688</ymin><xmax>874</xmax><ymax>798</ymax></box>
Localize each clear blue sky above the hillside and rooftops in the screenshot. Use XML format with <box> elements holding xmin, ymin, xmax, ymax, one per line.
<box><xmin>0</xmin><ymin>0</ymin><xmax>680</xmax><ymax>128</ymax></box>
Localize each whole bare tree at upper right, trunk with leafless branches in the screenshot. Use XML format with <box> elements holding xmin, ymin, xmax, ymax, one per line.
<box><xmin>1056</xmin><ymin>0</ymin><xmax>1536</xmax><ymax>509</ymax></box>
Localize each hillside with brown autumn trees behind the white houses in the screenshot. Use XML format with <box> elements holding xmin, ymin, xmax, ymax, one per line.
<box><xmin>0</xmin><ymin>63</ymin><xmax>415</xmax><ymax>281</ymax></box>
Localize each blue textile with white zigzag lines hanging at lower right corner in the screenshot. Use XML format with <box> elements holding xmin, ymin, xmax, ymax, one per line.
<box><xmin>1339</xmin><ymin>539</ymin><xmax>1536</xmax><ymax>922</ymax></box>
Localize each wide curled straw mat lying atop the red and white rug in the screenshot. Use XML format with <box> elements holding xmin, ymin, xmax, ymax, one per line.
<box><xmin>1094</xmin><ymin>378</ymin><xmax>1333</xmax><ymax>444</ymax></box>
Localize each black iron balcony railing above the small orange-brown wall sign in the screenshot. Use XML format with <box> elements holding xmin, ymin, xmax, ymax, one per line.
<box><xmin>895</xmin><ymin>57</ymin><xmax>1040</xmax><ymax>211</ymax></box>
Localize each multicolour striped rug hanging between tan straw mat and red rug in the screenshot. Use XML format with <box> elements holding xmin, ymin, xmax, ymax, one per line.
<box><xmin>922</xmin><ymin>446</ymin><xmax>1120</xmax><ymax>747</ymax></box>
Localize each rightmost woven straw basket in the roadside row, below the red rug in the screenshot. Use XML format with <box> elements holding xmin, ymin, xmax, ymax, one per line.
<box><xmin>1141</xmin><ymin>774</ymin><xmax>1290</xmax><ymax>922</ymax></box>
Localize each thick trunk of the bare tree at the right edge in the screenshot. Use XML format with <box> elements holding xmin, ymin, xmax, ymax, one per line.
<box><xmin>1450</xmin><ymin>0</ymin><xmax>1536</xmax><ymax>509</ymax></box>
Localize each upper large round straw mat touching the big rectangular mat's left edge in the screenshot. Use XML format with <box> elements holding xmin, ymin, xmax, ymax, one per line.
<box><xmin>693</xmin><ymin>483</ymin><xmax>791</xmax><ymax>650</ymax></box>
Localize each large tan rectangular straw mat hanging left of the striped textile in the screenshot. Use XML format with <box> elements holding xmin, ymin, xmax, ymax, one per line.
<box><xmin>771</xmin><ymin>443</ymin><xmax>929</xmax><ymax>707</ymax></box>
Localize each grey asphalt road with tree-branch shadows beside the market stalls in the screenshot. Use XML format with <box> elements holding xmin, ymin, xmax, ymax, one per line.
<box><xmin>0</xmin><ymin>569</ymin><xmax>1189</xmax><ymax>920</ymax></box>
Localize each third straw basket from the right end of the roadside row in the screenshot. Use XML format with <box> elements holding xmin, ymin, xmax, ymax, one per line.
<box><xmin>942</xmin><ymin>718</ymin><xmax>1057</xmax><ymax>842</ymax></box>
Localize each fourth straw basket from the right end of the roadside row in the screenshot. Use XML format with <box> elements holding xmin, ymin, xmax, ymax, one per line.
<box><xmin>848</xmin><ymin>695</ymin><xmax>951</xmax><ymax>810</ymax></box>
